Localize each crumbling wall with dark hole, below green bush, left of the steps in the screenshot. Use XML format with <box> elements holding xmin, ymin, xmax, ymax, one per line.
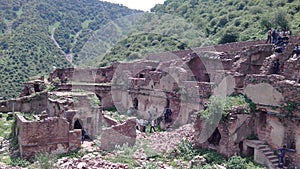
<box><xmin>194</xmin><ymin>114</ymin><xmax>254</xmax><ymax>157</ymax></box>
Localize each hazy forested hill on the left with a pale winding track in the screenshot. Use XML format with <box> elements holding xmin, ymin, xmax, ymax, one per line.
<box><xmin>0</xmin><ymin>0</ymin><xmax>140</xmax><ymax>98</ymax></box>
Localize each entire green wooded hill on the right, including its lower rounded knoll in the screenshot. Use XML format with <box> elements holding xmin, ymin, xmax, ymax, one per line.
<box><xmin>103</xmin><ymin>0</ymin><xmax>300</xmax><ymax>65</ymax></box>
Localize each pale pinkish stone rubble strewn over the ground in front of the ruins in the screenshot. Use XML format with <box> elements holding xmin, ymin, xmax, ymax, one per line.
<box><xmin>0</xmin><ymin>125</ymin><xmax>225</xmax><ymax>169</ymax></box>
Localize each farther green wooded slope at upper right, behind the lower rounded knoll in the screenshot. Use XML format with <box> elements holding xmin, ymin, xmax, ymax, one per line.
<box><xmin>152</xmin><ymin>0</ymin><xmax>300</xmax><ymax>43</ymax></box>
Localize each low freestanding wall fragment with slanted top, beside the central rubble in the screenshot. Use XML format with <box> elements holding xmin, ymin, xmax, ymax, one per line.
<box><xmin>100</xmin><ymin>118</ymin><xmax>136</xmax><ymax>150</ymax></box>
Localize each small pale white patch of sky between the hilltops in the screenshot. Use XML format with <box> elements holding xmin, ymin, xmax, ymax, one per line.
<box><xmin>103</xmin><ymin>0</ymin><xmax>165</xmax><ymax>11</ymax></box>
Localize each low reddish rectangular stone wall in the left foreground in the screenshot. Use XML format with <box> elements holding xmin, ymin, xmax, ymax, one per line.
<box><xmin>16</xmin><ymin>115</ymin><xmax>81</xmax><ymax>158</ymax></box>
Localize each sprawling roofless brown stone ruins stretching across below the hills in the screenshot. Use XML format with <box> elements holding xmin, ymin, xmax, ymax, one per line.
<box><xmin>0</xmin><ymin>36</ymin><xmax>300</xmax><ymax>168</ymax></box>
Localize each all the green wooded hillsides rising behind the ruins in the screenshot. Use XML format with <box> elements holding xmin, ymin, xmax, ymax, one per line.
<box><xmin>0</xmin><ymin>0</ymin><xmax>300</xmax><ymax>97</ymax></box>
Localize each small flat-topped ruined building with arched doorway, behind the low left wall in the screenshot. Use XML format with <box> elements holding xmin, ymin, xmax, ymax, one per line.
<box><xmin>47</xmin><ymin>92</ymin><xmax>102</xmax><ymax>139</ymax></box>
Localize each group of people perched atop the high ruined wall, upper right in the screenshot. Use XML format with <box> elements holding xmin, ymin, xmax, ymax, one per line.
<box><xmin>266</xmin><ymin>28</ymin><xmax>291</xmax><ymax>53</ymax></box>
